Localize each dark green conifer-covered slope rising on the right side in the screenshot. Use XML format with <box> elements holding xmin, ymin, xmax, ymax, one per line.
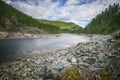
<box><xmin>84</xmin><ymin>3</ymin><xmax>120</xmax><ymax>34</ymax></box>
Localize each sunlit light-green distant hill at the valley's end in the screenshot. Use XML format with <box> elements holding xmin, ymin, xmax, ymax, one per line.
<box><xmin>38</xmin><ymin>19</ymin><xmax>83</xmax><ymax>33</ymax></box>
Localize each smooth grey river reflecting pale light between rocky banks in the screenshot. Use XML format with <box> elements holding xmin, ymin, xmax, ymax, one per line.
<box><xmin>0</xmin><ymin>34</ymin><xmax>89</xmax><ymax>63</ymax></box>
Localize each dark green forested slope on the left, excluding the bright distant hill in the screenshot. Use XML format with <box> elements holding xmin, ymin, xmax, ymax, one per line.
<box><xmin>0</xmin><ymin>0</ymin><xmax>60</xmax><ymax>33</ymax></box>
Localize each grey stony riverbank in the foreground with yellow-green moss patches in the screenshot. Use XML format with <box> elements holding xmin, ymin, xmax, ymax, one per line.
<box><xmin>0</xmin><ymin>35</ymin><xmax>120</xmax><ymax>80</ymax></box>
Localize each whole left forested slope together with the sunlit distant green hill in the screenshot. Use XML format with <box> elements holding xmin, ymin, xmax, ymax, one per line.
<box><xmin>0</xmin><ymin>0</ymin><xmax>82</xmax><ymax>33</ymax></box>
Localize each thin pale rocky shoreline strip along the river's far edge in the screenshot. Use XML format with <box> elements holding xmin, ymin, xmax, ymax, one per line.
<box><xmin>0</xmin><ymin>31</ymin><xmax>94</xmax><ymax>39</ymax></box>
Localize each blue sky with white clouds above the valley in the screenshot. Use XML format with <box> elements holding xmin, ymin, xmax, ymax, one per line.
<box><xmin>4</xmin><ymin>0</ymin><xmax>120</xmax><ymax>27</ymax></box>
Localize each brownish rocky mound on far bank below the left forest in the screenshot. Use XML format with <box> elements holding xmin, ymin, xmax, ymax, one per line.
<box><xmin>0</xmin><ymin>27</ymin><xmax>48</xmax><ymax>38</ymax></box>
